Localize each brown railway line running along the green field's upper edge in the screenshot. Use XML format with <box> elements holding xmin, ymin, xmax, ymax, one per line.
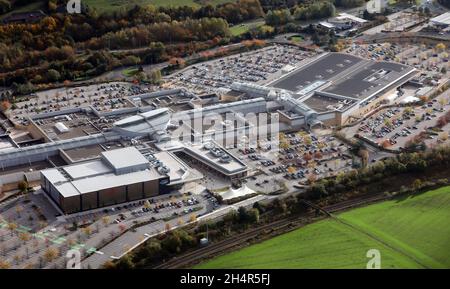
<box><xmin>152</xmin><ymin>194</ymin><xmax>388</xmax><ymax>269</ymax></box>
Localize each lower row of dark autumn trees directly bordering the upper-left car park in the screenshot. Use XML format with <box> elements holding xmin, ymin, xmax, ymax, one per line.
<box><xmin>0</xmin><ymin>39</ymin><xmax>220</xmax><ymax>89</ymax></box>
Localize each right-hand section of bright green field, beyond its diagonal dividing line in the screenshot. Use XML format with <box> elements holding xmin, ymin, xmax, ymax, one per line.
<box><xmin>340</xmin><ymin>187</ymin><xmax>450</xmax><ymax>268</ymax></box>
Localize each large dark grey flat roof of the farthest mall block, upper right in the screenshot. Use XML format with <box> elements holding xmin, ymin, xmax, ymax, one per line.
<box><xmin>271</xmin><ymin>53</ymin><xmax>415</xmax><ymax>103</ymax></box>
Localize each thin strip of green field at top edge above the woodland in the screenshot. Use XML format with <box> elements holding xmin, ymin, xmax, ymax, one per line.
<box><xmin>83</xmin><ymin>0</ymin><xmax>233</xmax><ymax>13</ymax></box>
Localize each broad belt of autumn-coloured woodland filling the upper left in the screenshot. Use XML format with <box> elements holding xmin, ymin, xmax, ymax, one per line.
<box><xmin>0</xmin><ymin>0</ymin><xmax>264</xmax><ymax>88</ymax></box>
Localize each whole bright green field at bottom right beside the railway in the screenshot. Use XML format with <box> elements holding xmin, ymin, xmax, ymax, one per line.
<box><xmin>195</xmin><ymin>187</ymin><xmax>450</xmax><ymax>268</ymax></box>
